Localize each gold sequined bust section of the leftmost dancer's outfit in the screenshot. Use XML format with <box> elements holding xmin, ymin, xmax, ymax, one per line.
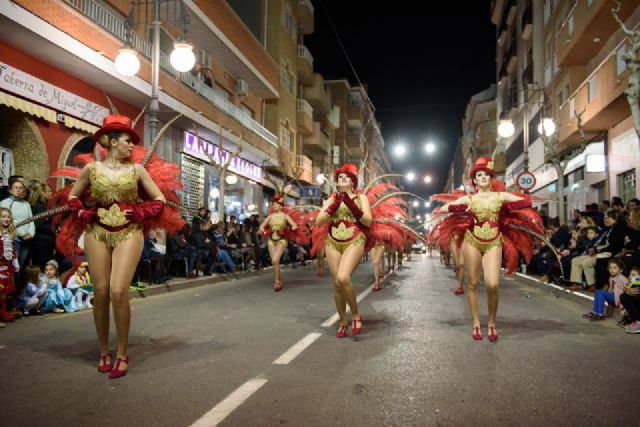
<box><xmin>89</xmin><ymin>163</ymin><xmax>138</xmax><ymax>205</ymax></box>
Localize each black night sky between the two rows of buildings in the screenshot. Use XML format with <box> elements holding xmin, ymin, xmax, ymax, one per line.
<box><xmin>304</xmin><ymin>0</ymin><xmax>496</xmax><ymax>201</ymax></box>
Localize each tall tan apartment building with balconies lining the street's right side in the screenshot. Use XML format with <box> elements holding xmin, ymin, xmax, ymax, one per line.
<box><xmin>491</xmin><ymin>0</ymin><xmax>640</xmax><ymax>216</ymax></box>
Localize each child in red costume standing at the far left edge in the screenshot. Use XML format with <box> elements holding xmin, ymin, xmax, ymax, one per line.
<box><xmin>0</xmin><ymin>208</ymin><xmax>20</xmax><ymax>328</ymax></box>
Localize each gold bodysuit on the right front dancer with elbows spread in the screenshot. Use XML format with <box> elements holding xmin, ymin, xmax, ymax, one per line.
<box><xmin>464</xmin><ymin>195</ymin><xmax>502</xmax><ymax>254</ymax></box>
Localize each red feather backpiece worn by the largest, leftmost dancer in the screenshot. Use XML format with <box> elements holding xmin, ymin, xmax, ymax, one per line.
<box><xmin>49</xmin><ymin>144</ymin><xmax>184</xmax><ymax>260</ymax></box>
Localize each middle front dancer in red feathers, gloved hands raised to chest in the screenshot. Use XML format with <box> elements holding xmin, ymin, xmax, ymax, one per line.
<box><xmin>310</xmin><ymin>163</ymin><xmax>416</xmax><ymax>338</ymax></box>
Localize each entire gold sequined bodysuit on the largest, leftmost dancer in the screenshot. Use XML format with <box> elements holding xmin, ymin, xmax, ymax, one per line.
<box><xmin>87</xmin><ymin>163</ymin><xmax>142</xmax><ymax>249</ymax></box>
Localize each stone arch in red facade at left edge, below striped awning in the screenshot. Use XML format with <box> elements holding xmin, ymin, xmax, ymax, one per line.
<box><xmin>0</xmin><ymin>106</ymin><xmax>49</xmax><ymax>181</ymax></box>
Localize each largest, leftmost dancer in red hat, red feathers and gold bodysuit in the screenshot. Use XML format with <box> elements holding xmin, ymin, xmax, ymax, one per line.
<box><xmin>50</xmin><ymin>114</ymin><xmax>183</xmax><ymax>378</ymax></box>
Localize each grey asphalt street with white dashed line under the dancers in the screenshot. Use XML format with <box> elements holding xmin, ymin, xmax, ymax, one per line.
<box><xmin>0</xmin><ymin>255</ymin><xmax>640</xmax><ymax>427</ymax></box>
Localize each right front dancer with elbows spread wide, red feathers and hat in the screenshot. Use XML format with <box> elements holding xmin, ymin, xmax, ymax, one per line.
<box><xmin>440</xmin><ymin>157</ymin><xmax>544</xmax><ymax>341</ymax></box>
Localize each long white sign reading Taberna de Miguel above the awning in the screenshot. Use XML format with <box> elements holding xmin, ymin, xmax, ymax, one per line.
<box><xmin>0</xmin><ymin>62</ymin><xmax>109</xmax><ymax>125</ymax></box>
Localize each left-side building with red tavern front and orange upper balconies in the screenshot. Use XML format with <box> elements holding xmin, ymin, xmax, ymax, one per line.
<box><xmin>0</xmin><ymin>0</ymin><xmax>282</xmax><ymax>216</ymax></box>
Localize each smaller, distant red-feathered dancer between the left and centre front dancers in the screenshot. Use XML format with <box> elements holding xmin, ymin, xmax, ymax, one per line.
<box><xmin>259</xmin><ymin>194</ymin><xmax>309</xmax><ymax>292</ymax></box>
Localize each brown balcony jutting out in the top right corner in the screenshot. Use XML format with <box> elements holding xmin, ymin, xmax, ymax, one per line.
<box><xmin>557</xmin><ymin>1</ymin><xmax>638</xmax><ymax>67</ymax></box>
